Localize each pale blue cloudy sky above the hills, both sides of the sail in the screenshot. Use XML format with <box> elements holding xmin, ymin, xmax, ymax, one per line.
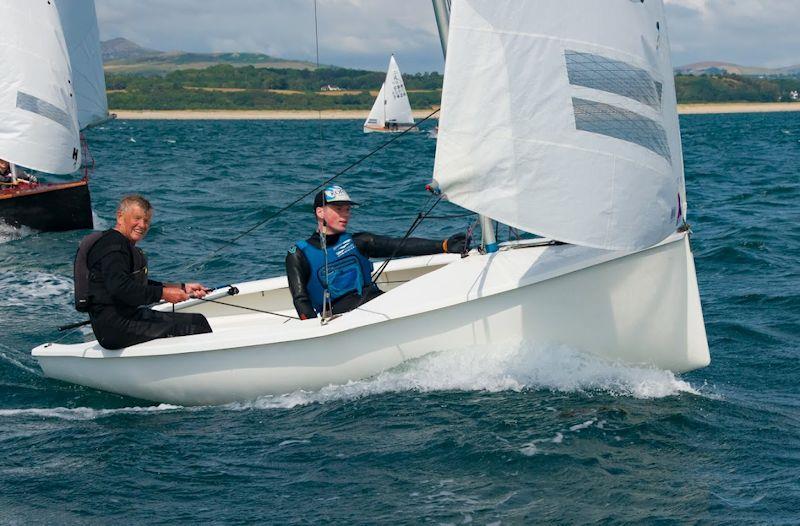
<box><xmin>95</xmin><ymin>0</ymin><xmax>800</xmax><ymax>73</ymax></box>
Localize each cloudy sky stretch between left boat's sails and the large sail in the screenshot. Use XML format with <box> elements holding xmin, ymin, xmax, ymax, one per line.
<box><xmin>97</xmin><ymin>0</ymin><xmax>443</xmax><ymax>72</ymax></box>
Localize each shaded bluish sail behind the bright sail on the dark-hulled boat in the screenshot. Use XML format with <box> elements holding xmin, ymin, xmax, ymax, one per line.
<box><xmin>56</xmin><ymin>0</ymin><xmax>108</xmax><ymax>129</ymax></box>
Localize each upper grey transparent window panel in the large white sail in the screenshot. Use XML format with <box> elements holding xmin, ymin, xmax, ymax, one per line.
<box><xmin>564</xmin><ymin>50</ymin><xmax>661</xmax><ymax>110</ymax></box>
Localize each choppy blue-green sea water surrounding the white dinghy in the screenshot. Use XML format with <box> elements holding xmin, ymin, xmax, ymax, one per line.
<box><xmin>0</xmin><ymin>114</ymin><xmax>800</xmax><ymax>524</ymax></box>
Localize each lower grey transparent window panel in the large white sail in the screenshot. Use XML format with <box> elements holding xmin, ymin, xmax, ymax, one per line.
<box><xmin>572</xmin><ymin>98</ymin><xmax>672</xmax><ymax>163</ymax></box>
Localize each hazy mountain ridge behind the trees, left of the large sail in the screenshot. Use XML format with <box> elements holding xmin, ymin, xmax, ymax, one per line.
<box><xmin>100</xmin><ymin>38</ymin><xmax>316</xmax><ymax>74</ymax></box>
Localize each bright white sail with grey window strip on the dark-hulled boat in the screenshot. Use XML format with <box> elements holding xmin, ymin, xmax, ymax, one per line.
<box><xmin>0</xmin><ymin>0</ymin><xmax>81</xmax><ymax>173</ymax></box>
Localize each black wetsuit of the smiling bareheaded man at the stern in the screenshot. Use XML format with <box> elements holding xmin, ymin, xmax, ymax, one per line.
<box><xmin>87</xmin><ymin>230</ymin><xmax>211</xmax><ymax>349</ymax></box>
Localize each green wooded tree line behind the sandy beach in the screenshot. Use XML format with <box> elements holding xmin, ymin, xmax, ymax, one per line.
<box><xmin>106</xmin><ymin>64</ymin><xmax>800</xmax><ymax>110</ymax></box>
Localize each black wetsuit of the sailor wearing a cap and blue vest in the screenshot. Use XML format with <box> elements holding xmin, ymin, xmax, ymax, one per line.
<box><xmin>286</xmin><ymin>232</ymin><xmax>442</xmax><ymax>319</ymax></box>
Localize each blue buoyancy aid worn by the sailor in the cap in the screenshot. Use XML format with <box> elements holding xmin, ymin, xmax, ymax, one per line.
<box><xmin>296</xmin><ymin>233</ymin><xmax>372</xmax><ymax>313</ymax></box>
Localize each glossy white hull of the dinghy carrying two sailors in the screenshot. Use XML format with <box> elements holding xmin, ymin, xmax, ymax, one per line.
<box><xmin>33</xmin><ymin>234</ymin><xmax>709</xmax><ymax>405</ymax></box>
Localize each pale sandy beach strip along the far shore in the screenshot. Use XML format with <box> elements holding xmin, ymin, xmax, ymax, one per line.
<box><xmin>110</xmin><ymin>102</ymin><xmax>800</xmax><ymax>120</ymax></box>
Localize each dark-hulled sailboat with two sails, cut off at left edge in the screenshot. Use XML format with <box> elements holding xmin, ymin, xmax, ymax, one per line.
<box><xmin>0</xmin><ymin>0</ymin><xmax>108</xmax><ymax>231</ymax></box>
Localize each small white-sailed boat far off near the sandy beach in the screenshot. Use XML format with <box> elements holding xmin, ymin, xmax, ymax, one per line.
<box><xmin>364</xmin><ymin>55</ymin><xmax>415</xmax><ymax>133</ymax></box>
